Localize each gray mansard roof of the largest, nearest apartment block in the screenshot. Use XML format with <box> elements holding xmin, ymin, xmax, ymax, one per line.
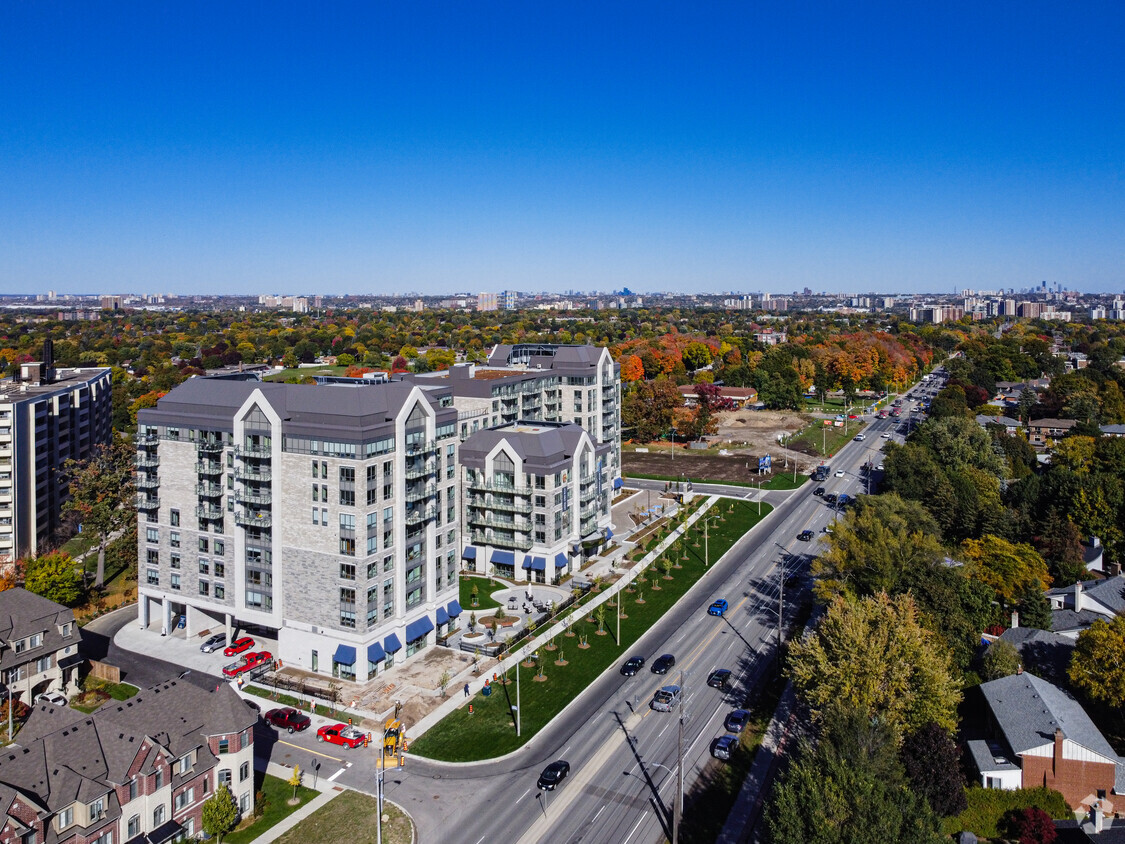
<box><xmin>137</xmin><ymin>378</ymin><xmax>457</xmax><ymax>440</ymax></box>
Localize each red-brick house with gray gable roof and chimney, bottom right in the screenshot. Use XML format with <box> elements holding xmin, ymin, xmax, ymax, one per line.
<box><xmin>968</xmin><ymin>672</ymin><xmax>1125</xmax><ymax>808</ymax></box>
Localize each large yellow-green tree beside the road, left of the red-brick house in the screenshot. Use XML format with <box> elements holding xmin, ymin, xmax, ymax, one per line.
<box><xmin>789</xmin><ymin>593</ymin><xmax>961</xmax><ymax>731</ymax></box>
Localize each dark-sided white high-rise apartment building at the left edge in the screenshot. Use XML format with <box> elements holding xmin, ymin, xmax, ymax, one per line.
<box><xmin>0</xmin><ymin>355</ymin><xmax>113</xmax><ymax>565</ymax></box>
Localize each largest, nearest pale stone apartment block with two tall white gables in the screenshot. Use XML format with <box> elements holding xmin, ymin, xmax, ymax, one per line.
<box><xmin>137</xmin><ymin>378</ymin><xmax>460</xmax><ymax>682</ymax></box>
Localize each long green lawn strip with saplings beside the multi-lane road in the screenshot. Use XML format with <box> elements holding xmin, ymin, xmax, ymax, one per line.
<box><xmin>411</xmin><ymin>501</ymin><xmax>771</xmax><ymax>762</ymax></box>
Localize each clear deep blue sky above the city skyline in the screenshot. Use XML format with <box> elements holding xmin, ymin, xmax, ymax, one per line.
<box><xmin>0</xmin><ymin>0</ymin><xmax>1125</xmax><ymax>294</ymax></box>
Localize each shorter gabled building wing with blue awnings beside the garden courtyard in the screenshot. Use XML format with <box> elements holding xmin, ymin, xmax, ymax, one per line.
<box><xmin>460</xmin><ymin>422</ymin><xmax>613</xmax><ymax>583</ymax></box>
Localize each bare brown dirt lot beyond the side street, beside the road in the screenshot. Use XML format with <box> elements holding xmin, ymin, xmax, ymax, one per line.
<box><xmin>621</xmin><ymin>410</ymin><xmax>819</xmax><ymax>482</ymax></box>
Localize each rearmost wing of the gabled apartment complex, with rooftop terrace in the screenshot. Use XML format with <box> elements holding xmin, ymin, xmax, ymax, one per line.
<box><xmin>404</xmin><ymin>343</ymin><xmax>621</xmax><ymax>488</ymax></box>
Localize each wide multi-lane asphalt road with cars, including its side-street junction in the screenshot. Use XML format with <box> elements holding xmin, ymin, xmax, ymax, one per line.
<box><xmin>94</xmin><ymin>378</ymin><xmax>940</xmax><ymax>844</ymax></box>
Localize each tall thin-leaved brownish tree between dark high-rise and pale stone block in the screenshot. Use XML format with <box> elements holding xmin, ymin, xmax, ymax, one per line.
<box><xmin>63</xmin><ymin>439</ymin><xmax>136</xmax><ymax>586</ymax></box>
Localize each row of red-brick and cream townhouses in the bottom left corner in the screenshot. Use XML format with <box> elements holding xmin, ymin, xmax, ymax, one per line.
<box><xmin>0</xmin><ymin>680</ymin><xmax>258</xmax><ymax>844</ymax></box>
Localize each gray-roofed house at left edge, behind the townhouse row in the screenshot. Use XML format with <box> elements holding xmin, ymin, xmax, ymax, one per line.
<box><xmin>0</xmin><ymin>589</ymin><xmax>82</xmax><ymax>704</ymax></box>
